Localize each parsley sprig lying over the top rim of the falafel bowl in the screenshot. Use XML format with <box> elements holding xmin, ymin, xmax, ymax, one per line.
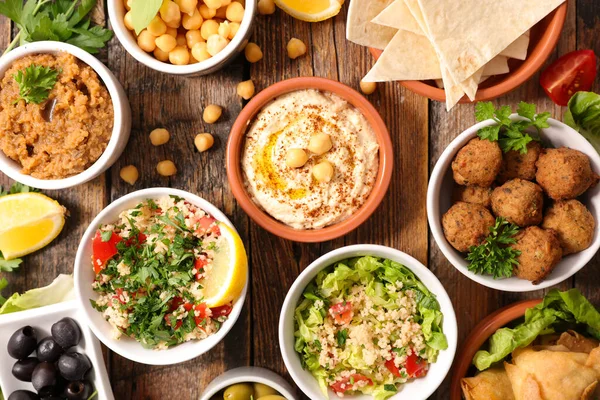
<box><xmin>475</xmin><ymin>101</ymin><xmax>550</xmax><ymax>154</ymax></box>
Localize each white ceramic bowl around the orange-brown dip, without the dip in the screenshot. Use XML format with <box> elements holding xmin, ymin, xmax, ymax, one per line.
<box><xmin>0</xmin><ymin>41</ymin><xmax>131</xmax><ymax>190</ymax></box>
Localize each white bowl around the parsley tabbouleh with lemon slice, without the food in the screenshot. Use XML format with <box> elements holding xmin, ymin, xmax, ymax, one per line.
<box><xmin>74</xmin><ymin>188</ymin><xmax>248</xmax><ymax>365</ymax></box>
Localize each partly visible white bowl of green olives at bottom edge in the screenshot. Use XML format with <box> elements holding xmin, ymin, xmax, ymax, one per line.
<box><xmin>200</xmin><ymin>367</ymin><xmax>297</xmax><ymax>400</ymax></box>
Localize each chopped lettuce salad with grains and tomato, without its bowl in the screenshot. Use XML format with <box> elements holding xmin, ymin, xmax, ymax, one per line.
<box><xmin>294</xmin><ymin>256</ymin><xmax>448</xmax><ymax>400</ymax></box>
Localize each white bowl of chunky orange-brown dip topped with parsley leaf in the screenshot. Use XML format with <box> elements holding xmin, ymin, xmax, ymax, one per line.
<box><xmin>0</xmin><ymin>42</ymin><xmax>131</xmax><ymax>189</ymax></box>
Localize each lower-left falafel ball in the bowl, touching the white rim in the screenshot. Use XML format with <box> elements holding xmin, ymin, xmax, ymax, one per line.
<box><xmin>442</xmin><ymin>201</ymin><xmax>496</xmax><ymax>253</ymax></box>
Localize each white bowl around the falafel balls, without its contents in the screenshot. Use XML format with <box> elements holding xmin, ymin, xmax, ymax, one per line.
<box><xmin>427</xmin><ymin>114</ymin><xmax>600</xmax><ymax>292</ymax></box>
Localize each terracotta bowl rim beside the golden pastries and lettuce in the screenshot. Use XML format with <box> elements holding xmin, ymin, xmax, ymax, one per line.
<box><xmin>450</xmin><ymin>299</ymin><xmax>542</xmax><ymax>400</ymax></box>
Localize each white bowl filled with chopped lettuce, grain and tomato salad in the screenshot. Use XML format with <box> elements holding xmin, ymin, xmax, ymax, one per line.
<box><xmin>279</xmin><ymin>245</ymin><xmax>457</xmax><ymax>400</ymax></box>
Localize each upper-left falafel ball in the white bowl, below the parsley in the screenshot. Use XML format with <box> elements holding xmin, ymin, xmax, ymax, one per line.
<box><xmin>452</xmin><ymin>138</ymin><xmax>502</xmax><ymax>187</ymax></box>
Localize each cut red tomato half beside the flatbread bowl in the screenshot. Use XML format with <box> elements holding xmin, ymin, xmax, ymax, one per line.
<box><xmin>540</xmin><ymin>50</ymin><xmax>596</xmax><ymax>106</ymax></box>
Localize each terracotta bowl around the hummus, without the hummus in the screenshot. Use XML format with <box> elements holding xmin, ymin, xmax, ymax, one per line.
<box><xmin>226</xmin><ymin>77</ymin><xmax>393</xmax><ymax>243</ymax></box>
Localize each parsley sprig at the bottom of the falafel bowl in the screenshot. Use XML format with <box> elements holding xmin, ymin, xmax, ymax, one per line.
<box><xmin>467</xmin><ymin>217</ymin><xmax>521</xmax><ymax>279</ymax></box>
